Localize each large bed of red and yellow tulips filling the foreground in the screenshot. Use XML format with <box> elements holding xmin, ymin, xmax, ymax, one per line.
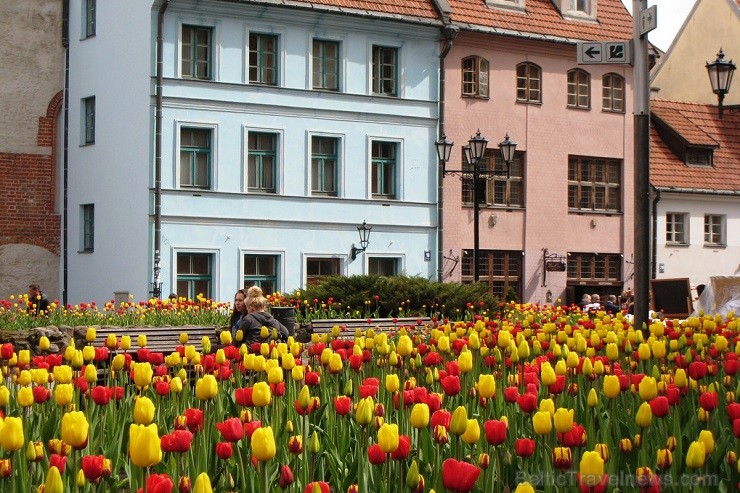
<box><xmin>0</xmin><ymin>298</ymin><xmax>740</xmax><ymax>493</ymax></box>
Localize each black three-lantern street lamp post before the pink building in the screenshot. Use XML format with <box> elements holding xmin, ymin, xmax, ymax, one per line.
<box><xmin>435</xmin><ymin>130</ymin><xmax>516</xmax><ymax>282</ymax></box>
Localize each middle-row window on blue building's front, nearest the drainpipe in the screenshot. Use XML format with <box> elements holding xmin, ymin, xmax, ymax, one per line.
<box><xmin>180</xmin><ymin>127</ymin><xmax>212</xmax><ymax>188</ymax></box>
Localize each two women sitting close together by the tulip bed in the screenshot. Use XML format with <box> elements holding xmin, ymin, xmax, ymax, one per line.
<box><xmin>229</xmin><ymin>286</ymin><xmax>289</xmax><ymax>346</ymax></box>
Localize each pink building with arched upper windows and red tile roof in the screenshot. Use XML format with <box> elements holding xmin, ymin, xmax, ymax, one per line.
<box><xmin>441</xmin><ymin>0</ymin><xmax>636</xmax><ymax>303</ymax></box>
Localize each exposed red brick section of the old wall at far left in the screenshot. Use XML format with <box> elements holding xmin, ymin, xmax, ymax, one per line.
<box><xmin>0</xmin><ymin>91</ymin><xmax>63</xmax><ymax>255</ymax></box>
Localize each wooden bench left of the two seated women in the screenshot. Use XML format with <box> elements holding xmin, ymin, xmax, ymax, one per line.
<box><xmin>73</xmin><ymin>325</ymin><xmax>221</xmax><ymax>356</ymax></box>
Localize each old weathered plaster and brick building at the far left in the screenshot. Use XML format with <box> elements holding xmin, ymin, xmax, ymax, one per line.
<box><xmin>0</xmin><ymin>0</ymin><xmax>64</xmax><ymax>298</ymax></box>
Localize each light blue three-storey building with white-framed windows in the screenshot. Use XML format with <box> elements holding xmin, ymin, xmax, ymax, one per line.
<box><xmin>63</xmin><ymin>0</ymin><xmax>441</xmax><ymax>303</ymax></box>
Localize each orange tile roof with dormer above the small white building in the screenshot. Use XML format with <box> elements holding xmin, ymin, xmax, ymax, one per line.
<box><xmin>650</xmin><ymin>99</ymin><xmax>740</xmax><ymax>192</ymax></box>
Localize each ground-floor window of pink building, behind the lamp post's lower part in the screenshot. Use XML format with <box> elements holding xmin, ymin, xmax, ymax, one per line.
<box><xmin>462</xmin><ymin>250</ymin><xmax>522</xmax><ymax>300</ymax></box>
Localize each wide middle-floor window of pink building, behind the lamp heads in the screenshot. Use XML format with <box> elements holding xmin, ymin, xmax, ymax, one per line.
<box><xmin>462</xmin><ymin>149</ymin><xmax>524</xmax><ymax>207</ymax></box>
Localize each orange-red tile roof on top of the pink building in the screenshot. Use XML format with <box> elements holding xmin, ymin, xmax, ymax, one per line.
<box><xmin>446</xmin><ymin>0</ymin><xmax>632</xmax><ymax>41</ymax></box>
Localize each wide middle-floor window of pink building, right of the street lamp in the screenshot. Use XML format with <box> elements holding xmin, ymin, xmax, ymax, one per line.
<box><xmin>568</xmin><ymin>156</ymin><xmax>621</xmax><ymax>212</ymax></box>
